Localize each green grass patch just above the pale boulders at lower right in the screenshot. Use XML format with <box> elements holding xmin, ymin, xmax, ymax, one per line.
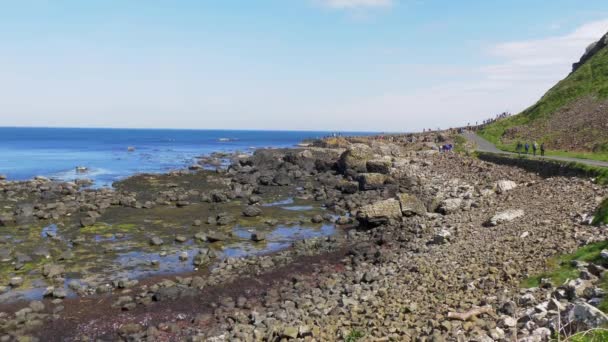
<box><xmin>520</xmin><ymin>240</ymin><xmax>608</xmax><ymax>313</ymax></box>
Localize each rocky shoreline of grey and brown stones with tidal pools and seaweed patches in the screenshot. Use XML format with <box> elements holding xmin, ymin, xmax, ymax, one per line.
<box><xmin>0</xmin><ymin>134</ymin><xmax>608</xmax><ymax>341</ymax></box>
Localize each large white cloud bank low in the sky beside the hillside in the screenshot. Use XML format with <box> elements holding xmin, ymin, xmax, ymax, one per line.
<box><xmin>314</xmin><ymin>19</ymin><xmax>608</xmax><ymax>131</ymax></box>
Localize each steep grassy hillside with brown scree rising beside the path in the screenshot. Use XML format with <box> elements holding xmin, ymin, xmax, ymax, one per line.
<box><xmin>480</xmin><ymin>34</ymin><xmax>608</xmax><ymax>154</ymax></box>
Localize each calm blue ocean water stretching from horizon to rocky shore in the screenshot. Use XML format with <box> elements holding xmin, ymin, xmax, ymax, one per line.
<box><xmin>0</xmin><ymin>127</ymin><xmax>365</xmax><ymax>186</ymax></box>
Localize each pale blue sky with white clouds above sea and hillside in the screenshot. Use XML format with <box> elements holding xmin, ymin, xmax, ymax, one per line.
<box><xmin>0</xmin><ymin>0</ymin><xmax>608</xmax><ymax>132</ymax></box>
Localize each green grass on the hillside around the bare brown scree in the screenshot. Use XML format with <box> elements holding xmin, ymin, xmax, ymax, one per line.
<box><xmin>479</xmin><ymin>43</ymin><xmax>608</xmax><ymax>160</ymax></box>
